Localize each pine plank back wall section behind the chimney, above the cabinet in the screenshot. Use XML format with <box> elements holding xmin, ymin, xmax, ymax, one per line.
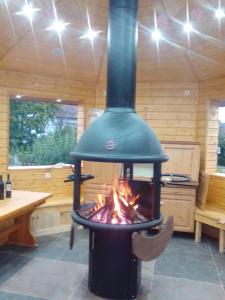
<box><xmin>95</xmin><ymin>82</ymin><xmax>198</xmax><ymax>141</ymax></box>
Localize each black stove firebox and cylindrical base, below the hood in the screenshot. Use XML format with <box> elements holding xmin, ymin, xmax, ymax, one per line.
<box><xmin>72</xmin><ymin>160</ymin><xmax>168</xmax><ymax>299</ymax></box>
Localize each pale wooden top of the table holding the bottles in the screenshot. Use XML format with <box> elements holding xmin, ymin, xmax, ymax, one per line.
<box><xmin>0</xmin><ymin>190</ymin><xmax>52</xmax><ymax>221</ymax></box>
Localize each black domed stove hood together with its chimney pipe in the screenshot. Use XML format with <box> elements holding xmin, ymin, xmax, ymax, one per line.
<box><xmin>72</xmin><ymin>0</ymin><xmax>168</xmax><ymax>163</ymax></box>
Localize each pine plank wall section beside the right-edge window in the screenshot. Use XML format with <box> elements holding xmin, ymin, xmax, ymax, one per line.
<box><xmin>198</xmin><ymin>77</ymin><xmax>225</xmax><ymax>173</ymax></box>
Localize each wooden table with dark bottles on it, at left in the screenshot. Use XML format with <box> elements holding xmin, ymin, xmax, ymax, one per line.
<box><xmin>0</xmin><ymin>190</ymin><xmax>52</xmax><ymax>247</ymax></box>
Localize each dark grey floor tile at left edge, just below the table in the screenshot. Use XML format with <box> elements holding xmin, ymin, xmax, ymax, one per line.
<box><xmin>0</xmin><ymin>253</ymin><xmax>32</xmax><ymax>284</ymax></box>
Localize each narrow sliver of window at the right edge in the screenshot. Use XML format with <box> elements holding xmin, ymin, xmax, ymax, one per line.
<box><xmin>217</xmin><ymin>107</ymin><xmax>225</xmax><ymax>173</ymax></box>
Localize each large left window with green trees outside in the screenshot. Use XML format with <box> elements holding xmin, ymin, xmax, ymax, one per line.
<box><xmin>9</xmin><ymin>98</ymin><xmax>77</xmax><ymax>166</ymax></box>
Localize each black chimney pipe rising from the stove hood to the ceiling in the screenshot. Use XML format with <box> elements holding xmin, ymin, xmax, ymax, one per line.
<box><xmin>107</xmin><ymin>0</ymin><xmax>138</xmax><ymax>109</ymax></box>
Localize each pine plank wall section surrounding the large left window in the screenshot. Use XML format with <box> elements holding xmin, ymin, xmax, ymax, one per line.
<box><xmin>0</xmin><ymin>70</ymin><xmax>95</xmax><ymax>198</ymax></box>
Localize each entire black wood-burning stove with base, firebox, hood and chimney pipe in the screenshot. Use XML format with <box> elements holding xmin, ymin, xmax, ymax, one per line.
<box><xmin>69</xmin><ymin>0</ymin><xmax>175</xmax><ymax>299</ymax></box>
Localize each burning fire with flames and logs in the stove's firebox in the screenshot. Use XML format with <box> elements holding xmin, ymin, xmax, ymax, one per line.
<box><xmin>89</xmin><ymin>181</ymin><xmax>139</xmax><ymax>224</ymax></box>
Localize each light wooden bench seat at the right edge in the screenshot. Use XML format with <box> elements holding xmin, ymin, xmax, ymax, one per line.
<box><xmin>195</xmin><ymin>172</ymin><xmax>225</xmax><ymax>253</ymax></box>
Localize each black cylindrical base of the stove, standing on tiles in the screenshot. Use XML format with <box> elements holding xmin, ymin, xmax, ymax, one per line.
<box><xmin>89</xmin><ymin>230</ymin><xmax>141</xmax><ymax>299</ymax></box>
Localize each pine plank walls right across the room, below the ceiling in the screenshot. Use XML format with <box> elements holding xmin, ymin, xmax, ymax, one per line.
<box><xmin>0</xmin><ymin>70</ymin><xmax>220</xmax><ymax>199</ymax></box>
